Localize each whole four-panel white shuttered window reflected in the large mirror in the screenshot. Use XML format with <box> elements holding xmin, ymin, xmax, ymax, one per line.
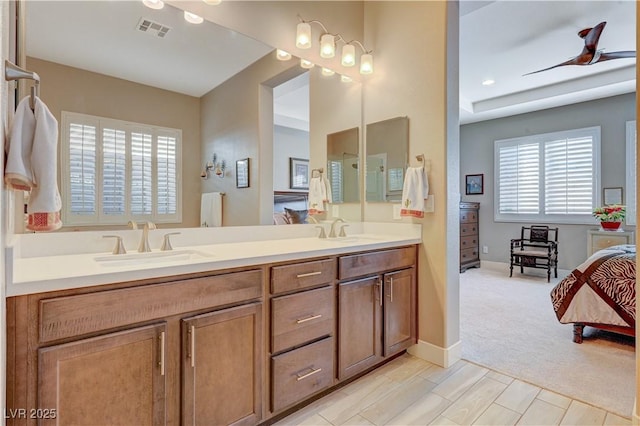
<box><xmin>61</xmin><ymin>111</ymin><xmax>182</xmax><ymax>225</ymax></box>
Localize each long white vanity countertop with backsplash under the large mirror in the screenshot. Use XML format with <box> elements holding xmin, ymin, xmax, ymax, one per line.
<box><xmin>6</xmin><ymin>223</ymin><xmax>422</xmax><ymax>297</ymax></box>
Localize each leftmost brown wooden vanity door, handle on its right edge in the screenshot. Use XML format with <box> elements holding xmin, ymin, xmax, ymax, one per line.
<box><xmin>38</xmin><ymin>324</ymin><xmax>166</xmax><ymax>425</ymax></box>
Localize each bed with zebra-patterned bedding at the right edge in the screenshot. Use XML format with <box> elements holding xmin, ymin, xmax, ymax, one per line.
<box><xmin>551</xmin><ymin>245</ymin><xmax>636</xmax><ymax>343</ymax></box>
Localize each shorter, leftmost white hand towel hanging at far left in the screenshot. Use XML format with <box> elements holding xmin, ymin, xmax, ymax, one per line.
<box><xmin>4</xmin><ymin>97</ymin><xmax>36</xmax><ymax>191</ymax></box>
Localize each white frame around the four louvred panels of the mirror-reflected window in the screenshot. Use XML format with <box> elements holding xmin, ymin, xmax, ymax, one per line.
<box><xmin>60</xmin><ymin>111</ymin><xmax>182</xmax><ymax>226</ymax></box>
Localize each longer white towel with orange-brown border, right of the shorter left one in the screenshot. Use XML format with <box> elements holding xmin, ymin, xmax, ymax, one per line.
<box><xmin>27</xmin><ymin>97</ymin><xmax>62</xmax><ymax>231</ymax></box>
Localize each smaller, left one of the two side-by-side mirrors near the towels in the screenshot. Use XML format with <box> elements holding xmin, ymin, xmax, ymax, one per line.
<box><xmin>327</xmin><ymin>127</ymin><xmax>360</xmax><ymax>203</ymax></box>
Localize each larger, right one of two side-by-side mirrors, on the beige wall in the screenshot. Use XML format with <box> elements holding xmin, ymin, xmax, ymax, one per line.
<box><xmin>366</xmin><ymin>117</ymin><xmax>409</xmax><ymax>202</ymax></box>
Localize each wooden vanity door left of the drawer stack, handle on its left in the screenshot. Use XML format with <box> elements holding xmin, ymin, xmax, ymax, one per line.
<box><xmin>182</xmin><ymin>303</ymin><xmax>262</xmax><ymax>425</ymax></box>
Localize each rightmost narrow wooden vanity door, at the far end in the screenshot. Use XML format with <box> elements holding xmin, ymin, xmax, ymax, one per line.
<box><xmin>384</xmin><ymin>268</ymin><xmax>416</xmax><ymax>356</ymax></box>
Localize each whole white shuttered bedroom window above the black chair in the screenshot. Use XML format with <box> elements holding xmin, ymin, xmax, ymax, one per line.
<box><xmin>494</xmin><ymin>127</ymin><xmax>600</xmax><ymax>223</ymax></box>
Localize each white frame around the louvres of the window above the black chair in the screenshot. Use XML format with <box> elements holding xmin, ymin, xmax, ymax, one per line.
<box><xmin>493</xmin><ymin>126</ymin><xmax>601</xmax><ymax>225</ymax></box>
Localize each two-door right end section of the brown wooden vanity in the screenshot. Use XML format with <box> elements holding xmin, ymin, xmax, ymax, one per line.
<box><xmin>338</xmin><ymin>246</ymin><xmax>417</xmax><ymax>380</ymax></box>
